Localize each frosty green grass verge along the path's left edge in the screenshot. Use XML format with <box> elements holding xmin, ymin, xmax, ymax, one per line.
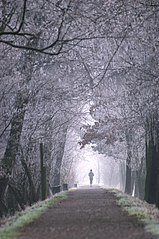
<box><xmin>0</xmin><ymin>193</ymin><xmax>67</xmax><ymax>239</ymax></box>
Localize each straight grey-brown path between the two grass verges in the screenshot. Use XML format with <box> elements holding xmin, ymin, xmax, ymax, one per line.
<box><xmin>16</xmin><ymin>187</ymin><xmax>155</xmax><ymax>239</ymax></box>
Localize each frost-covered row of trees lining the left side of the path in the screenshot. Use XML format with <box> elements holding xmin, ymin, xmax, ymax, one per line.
<box><xmin>0</xmin><ymin>0</ymin><xmax>95</xmax><ymax>215</ymax></box>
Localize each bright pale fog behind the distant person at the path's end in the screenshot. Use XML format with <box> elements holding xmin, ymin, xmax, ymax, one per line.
<box><xmin>76</xmin><ymin>145</ymin><xmax>121</xmax><ymax>188</ymax></box>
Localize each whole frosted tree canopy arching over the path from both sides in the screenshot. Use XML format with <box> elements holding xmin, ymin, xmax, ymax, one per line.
<box><xmin>0</xmin><ymin>0</ymin><xmax>159</xmax><ymax>215</ymax></box>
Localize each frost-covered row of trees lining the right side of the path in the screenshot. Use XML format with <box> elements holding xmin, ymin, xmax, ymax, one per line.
<box><xmin>80</xmin><ymin>1</ymin><xmax>159</xmax><ymax>207</ymax></box>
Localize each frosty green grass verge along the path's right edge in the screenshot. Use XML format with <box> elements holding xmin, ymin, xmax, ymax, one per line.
<box><xmin>110</xmin><ymin>189</ymin><xmax>159</xmax><ymax>236</ymax></box>
